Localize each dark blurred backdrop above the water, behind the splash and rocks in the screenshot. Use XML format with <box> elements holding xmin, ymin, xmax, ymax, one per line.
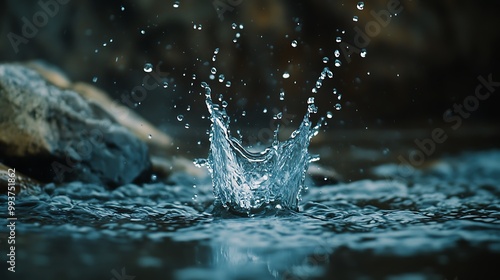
<box><xmin>0</xmin><ymin>0</ymin><xmax>500</xmax><ymax>178</ymax></box>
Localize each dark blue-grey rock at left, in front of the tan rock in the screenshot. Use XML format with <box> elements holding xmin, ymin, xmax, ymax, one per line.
<box><xmin>0</xmin><ymin>64</ymin><xmax>151</xmax><ymax>186</ymax></box>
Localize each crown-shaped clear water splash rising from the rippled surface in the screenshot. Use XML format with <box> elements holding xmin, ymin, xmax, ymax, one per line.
<box><xmin>197</xmin><ymin>83</ymin><xmax>323</xmax><ymax>215</ymax></box>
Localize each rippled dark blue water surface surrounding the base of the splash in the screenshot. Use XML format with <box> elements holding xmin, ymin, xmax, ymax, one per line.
<box><xmin>0</xmin><ymin>150</ymin><xmax>500</xmax><ymax>280</ymax></box>
